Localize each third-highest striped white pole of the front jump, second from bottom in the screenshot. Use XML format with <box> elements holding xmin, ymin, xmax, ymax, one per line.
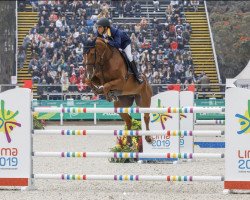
<box><xmin>33</xmin><ymin>152</ymin><xmax>224</xmax><ymax>159</ymax></box>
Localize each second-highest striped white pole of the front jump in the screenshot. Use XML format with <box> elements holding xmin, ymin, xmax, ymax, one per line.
<box><xmin>33</xmin><ymin>129</ymin><xmax>224</xmax><ymax>137</ymax></box>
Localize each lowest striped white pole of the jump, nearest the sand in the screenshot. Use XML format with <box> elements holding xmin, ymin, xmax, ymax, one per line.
<box><xmin>33</xmin><ymin>174</ymin><xmax>224</xmax><ymax>182</ymax></box>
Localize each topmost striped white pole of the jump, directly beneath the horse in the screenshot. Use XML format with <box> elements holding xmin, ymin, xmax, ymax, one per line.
<box><xmin>34</xmin><ymin>107</ymin><xmax>225</xmax><ymax>113</ymax></box>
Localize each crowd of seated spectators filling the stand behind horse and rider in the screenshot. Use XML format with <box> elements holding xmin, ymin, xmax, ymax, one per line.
<box><xmin>18</xmin><ymin>0</ymin><xmax>195</xmax><ymax>98</ymax></box>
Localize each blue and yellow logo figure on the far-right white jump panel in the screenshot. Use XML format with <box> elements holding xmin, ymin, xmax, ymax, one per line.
<box><xmin>235</xmin><ymin>100</ymin><xmax>250</xmax><ymax>135</ymax></box>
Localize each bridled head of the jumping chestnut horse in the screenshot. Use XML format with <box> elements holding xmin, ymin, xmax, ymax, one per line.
<box><xmin>84</xmin><ymin>38</ymin><xmax>111</xmax><ymax>81</ymax></box>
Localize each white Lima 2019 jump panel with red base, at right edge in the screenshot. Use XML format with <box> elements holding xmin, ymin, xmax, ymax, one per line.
<box><xmin>225</xmin><ymin>88</ymin><xmax>250</xmax><ymax>190</ymax></box>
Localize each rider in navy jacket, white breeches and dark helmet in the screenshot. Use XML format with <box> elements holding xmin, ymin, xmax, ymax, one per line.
<box><xmin>96</xmin><ymin>18</ymin><xmax>143</xmax><ymax>84</ymax></box>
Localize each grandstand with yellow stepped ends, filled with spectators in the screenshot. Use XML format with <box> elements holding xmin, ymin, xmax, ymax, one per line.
<box><xmin>18</xmin><ymin>0</ymin><xmax>221</xmax><ymax>98</ymax></box>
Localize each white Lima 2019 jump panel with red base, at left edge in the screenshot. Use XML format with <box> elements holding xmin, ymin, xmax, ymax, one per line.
<box><xmin>0</xmin><ymin>88</ymin><xmax>32</xmax><ymax>186</ymax></box>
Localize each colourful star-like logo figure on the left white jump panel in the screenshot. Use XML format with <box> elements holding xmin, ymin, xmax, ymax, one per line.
<box><xmin>0</xmin><ymin>100</ymin><xmax>21</xmax><ymax>143</ymax></box>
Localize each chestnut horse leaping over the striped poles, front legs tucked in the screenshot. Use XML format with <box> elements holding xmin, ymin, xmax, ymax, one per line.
<box><xmin>84</xmin><ymin>37</ymin><xmax>152</xmax><ymax>142</ymax></box>
